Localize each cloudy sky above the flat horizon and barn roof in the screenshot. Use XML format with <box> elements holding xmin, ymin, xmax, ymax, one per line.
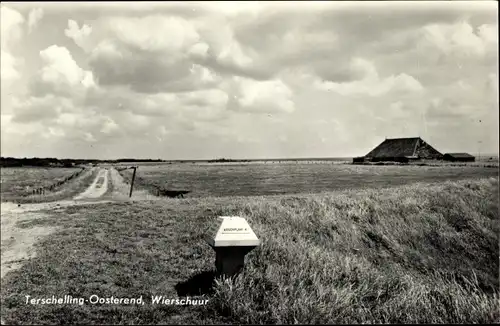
<box><xmin>1</xmin><ymin>1</ymin><xmax>499</xmax><ymax>160</ymax></box>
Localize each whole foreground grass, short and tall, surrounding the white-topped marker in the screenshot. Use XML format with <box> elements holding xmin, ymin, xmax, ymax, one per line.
<box><xmin>1</xmin><ymin>174</ymin><xmax>500</xmax><ymax>324</ymax></box>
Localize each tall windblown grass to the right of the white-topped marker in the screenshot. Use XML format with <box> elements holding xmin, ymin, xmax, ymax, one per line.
<box><xmin>207</xmin><ymin>179</ymin><xmax>499</xmax><ymax>324</ymax></box>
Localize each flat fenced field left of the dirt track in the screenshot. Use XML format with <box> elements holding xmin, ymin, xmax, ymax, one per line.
<box><xmin>0</xmin><ymin>167</ymin><xmax>80</xmax><ymax>200</ymax></box>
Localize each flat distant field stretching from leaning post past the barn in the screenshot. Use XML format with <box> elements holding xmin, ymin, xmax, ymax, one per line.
<box><xmin>120</xmin><ymin>162</ymin><xmax>498</xmax><ymax>197</ymax></box>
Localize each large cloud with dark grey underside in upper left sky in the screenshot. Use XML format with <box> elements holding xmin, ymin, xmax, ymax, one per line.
<box><xmin>65</xmin><ymin>15</ymin><xmax>219</xmax><ymax>93</ymax></box>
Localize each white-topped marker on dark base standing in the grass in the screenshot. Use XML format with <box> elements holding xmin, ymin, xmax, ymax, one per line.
<box><xmin>205</xmin><ymin>216</ymin><xmax>260</xmax><ymax>277</ymax></box>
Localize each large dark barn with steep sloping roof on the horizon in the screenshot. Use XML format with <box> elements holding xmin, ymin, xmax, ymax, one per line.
<box><xmin>353</xmin><ymin>137</ymin><xmax>443</xmax><ymax>163</ymax></box>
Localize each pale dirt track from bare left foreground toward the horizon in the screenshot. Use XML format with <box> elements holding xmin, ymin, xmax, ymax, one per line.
<box><xmin>0</xmin><ymin>169</ymin><xmax>110</xmax><ymax>278</ymax></box>
